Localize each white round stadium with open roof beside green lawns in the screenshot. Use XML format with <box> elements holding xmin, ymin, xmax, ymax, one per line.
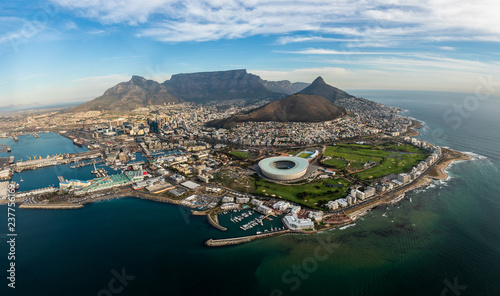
<box><xmin>259</xmin><ymin>156</ymin><xmax>309</xmax><ymax>181</ymax></box>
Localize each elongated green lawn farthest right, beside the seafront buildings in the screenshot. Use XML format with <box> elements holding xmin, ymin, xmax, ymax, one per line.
<box><xmin>356</xmin><ymin>152</ymin><xmax>427</xmax><ymax>180</ymax></box>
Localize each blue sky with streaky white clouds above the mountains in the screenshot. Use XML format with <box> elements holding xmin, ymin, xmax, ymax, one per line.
<box><xmin>0</xmin><ymin>0</ymin><xmax>500</xmax><ymax>106</ymax></box>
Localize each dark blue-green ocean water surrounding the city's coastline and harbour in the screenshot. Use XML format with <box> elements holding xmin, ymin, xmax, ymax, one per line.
<box><xmin>0</xmin><ymin>90</ymin><xmax>500</xmax><ymax>296</ymax></box>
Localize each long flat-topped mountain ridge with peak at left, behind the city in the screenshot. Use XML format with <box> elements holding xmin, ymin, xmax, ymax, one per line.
<box><xmin>72</xmin><ymin>69</ymin><xmax>294</xmax><ymax>112</ymax></box>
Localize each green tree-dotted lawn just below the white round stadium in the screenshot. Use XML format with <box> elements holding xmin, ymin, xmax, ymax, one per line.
<box><xmin>255</xmin><ymin>177</ymin><xmax>351</xmax><ymax>209</ymax></box>
